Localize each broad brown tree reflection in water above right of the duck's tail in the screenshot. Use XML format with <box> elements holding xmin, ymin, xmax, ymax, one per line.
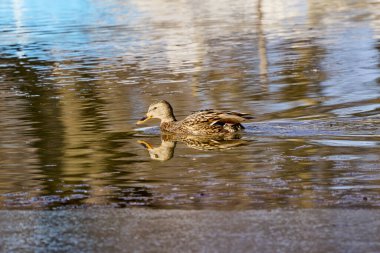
<box><xmin>262</xmin><ymin>38</ymin><xmax>326</xmax><ymax>121</ymax></box>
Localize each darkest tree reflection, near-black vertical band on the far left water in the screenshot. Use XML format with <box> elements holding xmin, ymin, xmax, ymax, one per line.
<box><xmin>2</xmin><ymin>55</ymin><xmax>64</xmax><ymax>198</ymax></box>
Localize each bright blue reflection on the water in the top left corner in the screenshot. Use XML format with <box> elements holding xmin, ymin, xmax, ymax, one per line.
<box><xmin>0</xmin><ymin>0</ymin><xmax>138</xmax><ymax>60</ymax></box>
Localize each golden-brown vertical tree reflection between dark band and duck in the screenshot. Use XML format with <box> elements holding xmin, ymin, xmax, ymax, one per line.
<box><xmin>48</xmin><ymin>62</ymin><xmax>149</xmax><ymax>207</ymax></box>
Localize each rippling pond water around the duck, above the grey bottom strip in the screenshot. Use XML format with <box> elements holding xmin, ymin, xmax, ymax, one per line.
<box><xmin>0</xmin><ymin>0</ymin><xmax>380</xmax><ymax>210</ymax></box>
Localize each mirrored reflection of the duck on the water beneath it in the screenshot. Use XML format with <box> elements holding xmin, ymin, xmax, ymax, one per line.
<box><xmin>137</xmin><ymin>134</ymin><xmax>247</xmax><ymax>161</ymax></box>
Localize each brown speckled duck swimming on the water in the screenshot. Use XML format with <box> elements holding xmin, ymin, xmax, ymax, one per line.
<box><xmin>137</xmin><ymin>100</ymin><xmax>253</xmax><ymax>136</ymax></box>
